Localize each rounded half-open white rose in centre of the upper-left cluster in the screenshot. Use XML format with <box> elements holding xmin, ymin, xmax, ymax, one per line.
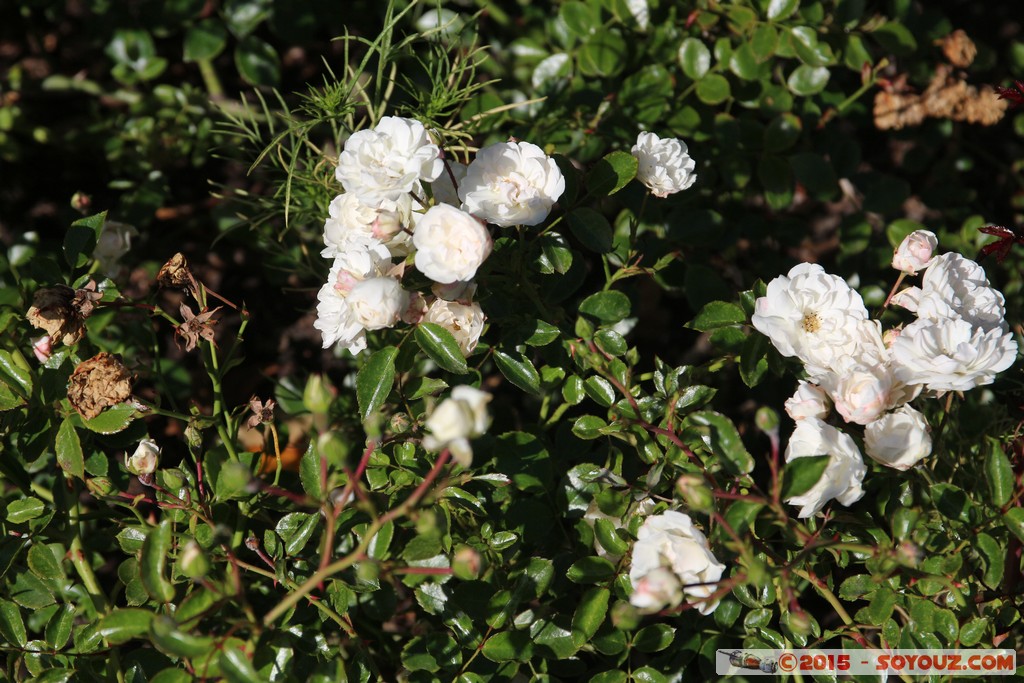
<box><xmin>413</xmin><ymin>204</ymin><xmax>492</xmax><ymax>284</ymax></box>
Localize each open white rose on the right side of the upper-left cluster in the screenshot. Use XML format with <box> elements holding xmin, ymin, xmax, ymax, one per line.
<box><xmin>459</xmin><ymin>142</ymin><xmax>565</xmax><ymax>227</ymax></box>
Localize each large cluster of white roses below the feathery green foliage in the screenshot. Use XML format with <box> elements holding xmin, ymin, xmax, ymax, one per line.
<box><xmin>313</xmin><ymin>117</ymin><xmax>565</xmax><ymax>355</ymax></box>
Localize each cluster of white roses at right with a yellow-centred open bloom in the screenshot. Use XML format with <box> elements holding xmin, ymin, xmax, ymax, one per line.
<box><xmin>752</xmin><ymin>230</ymin><xmax>1017</xmax><ymax>517</ymax></box>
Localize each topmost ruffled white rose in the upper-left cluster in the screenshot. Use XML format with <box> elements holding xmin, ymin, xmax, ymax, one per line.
<box><xmin>335</xmin><ymin>117</ymin><xmax>444</xmax><ymax>206</ymax></box>
